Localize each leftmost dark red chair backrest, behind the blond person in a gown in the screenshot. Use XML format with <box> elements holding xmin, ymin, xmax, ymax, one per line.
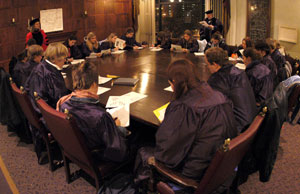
<box><xmin>10</xmin><ymin>78</ymin><xmax>42</xmax><ymax>129</ymax></box>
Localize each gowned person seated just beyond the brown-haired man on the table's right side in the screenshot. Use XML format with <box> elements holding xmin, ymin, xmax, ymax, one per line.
<box><xmin>243</xmin><ymin>48</ymin><xmax>273</xmax><ymax>105</ymax></box>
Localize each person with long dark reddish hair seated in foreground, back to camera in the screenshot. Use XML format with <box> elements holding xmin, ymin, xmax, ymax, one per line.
<box><xmin>135</xmin><ymin>59</ymin><xmax>238</xmax><ymax>193</ymax></box>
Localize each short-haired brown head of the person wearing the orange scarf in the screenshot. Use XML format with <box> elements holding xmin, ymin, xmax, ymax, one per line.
<box><xmin>72</xmin><ymin>61</ymin><xmax>98</xmax><ymax>94</ymax></box>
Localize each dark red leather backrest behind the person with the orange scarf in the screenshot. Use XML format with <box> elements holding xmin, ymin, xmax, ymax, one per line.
<box><xmin>35</xmin><ymin>93</ymin><xmax>94</xmax><ymax>172</ymax></box>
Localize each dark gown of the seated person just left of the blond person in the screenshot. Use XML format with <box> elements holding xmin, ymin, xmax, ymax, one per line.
<box><xmin>12</xmin><ymin>60</ymin><xmax>38</xmax><ymax>87</ymax></box>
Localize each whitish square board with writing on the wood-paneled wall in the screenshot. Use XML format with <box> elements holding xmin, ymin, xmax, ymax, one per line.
<box><xmin>40</xmin><ymin>8</ymin><xmax>64</xmax><ymax>33</ymax></box>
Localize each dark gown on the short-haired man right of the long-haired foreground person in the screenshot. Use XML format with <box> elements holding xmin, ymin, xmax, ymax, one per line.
<box><xmin>208</xmin><ymin>64</ymin><xmax>258</xmax><ymax>132</ymax></box>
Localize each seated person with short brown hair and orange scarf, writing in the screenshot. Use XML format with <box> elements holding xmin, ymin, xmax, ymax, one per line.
<box><xmin>57</xmin><ymin>62</ymin><xmax>127</xmax><ymax>162</ymax></box>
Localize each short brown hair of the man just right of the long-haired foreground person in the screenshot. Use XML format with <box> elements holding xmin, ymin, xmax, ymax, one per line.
<box><xmin>205</xmin><ymin>47</ymin><xmax>228</xmax><ymax>66</ymax></box>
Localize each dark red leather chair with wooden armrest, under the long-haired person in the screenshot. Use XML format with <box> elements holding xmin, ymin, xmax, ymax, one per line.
<box><xmin>148</xmin><ymin>107</ymin><xmax>267</xmax><ymax>194</ymax></box>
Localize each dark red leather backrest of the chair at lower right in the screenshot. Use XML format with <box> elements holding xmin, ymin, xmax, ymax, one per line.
<box><xmin>195</xmin><ymin>108</ymin><xmax>267</xmax><ymax>194</ymax></box>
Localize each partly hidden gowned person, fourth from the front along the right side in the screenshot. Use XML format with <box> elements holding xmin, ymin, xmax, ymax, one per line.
<box><xmin>255</xmin><ymin>42</ymin><xmax>278</xmax><ymax>84</ymax></box>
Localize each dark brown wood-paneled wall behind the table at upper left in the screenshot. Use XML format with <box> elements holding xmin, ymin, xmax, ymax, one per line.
<box><xmin>0</xmin><ymin>0</ymin><xmax>132</xmax><ymax>69</ymax></box>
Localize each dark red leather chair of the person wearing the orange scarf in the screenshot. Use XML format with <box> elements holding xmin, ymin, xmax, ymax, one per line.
<box><xmin>34</xmin><ymin>93</ymin><xmax>120</xmax><ymax>191</ymax></box>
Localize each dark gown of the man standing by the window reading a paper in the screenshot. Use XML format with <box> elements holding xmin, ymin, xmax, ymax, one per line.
<box><xmin>200</xmin><ymin>17</ymin><xmax>223</xmax><ymax>42</ymax></box>
